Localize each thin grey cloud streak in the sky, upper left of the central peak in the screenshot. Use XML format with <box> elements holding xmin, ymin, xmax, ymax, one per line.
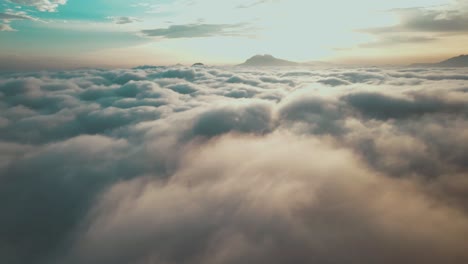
<box><xmin>141</xmin><ymin>24</ymin><xmax>247</xmax><ymax>38</ymax></box>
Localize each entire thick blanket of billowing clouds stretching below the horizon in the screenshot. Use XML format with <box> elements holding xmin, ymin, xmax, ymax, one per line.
<box><xmin>0</xmin><ymin>66</ymin><xmax>468</xmax><ymax>264</ymax></box>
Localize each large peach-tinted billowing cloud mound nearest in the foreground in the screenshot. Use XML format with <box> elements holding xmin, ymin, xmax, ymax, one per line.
<box><xmin>66</xmin><ymin>134</ymin><xmax>468</xmax><ymax>263</ymax></box>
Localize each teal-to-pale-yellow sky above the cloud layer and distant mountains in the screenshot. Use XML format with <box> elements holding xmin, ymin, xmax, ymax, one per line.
<box><xmin>0</xmin><ymin>0</ymin><xmax>468</xmax><ymax>70</ymax></box>
